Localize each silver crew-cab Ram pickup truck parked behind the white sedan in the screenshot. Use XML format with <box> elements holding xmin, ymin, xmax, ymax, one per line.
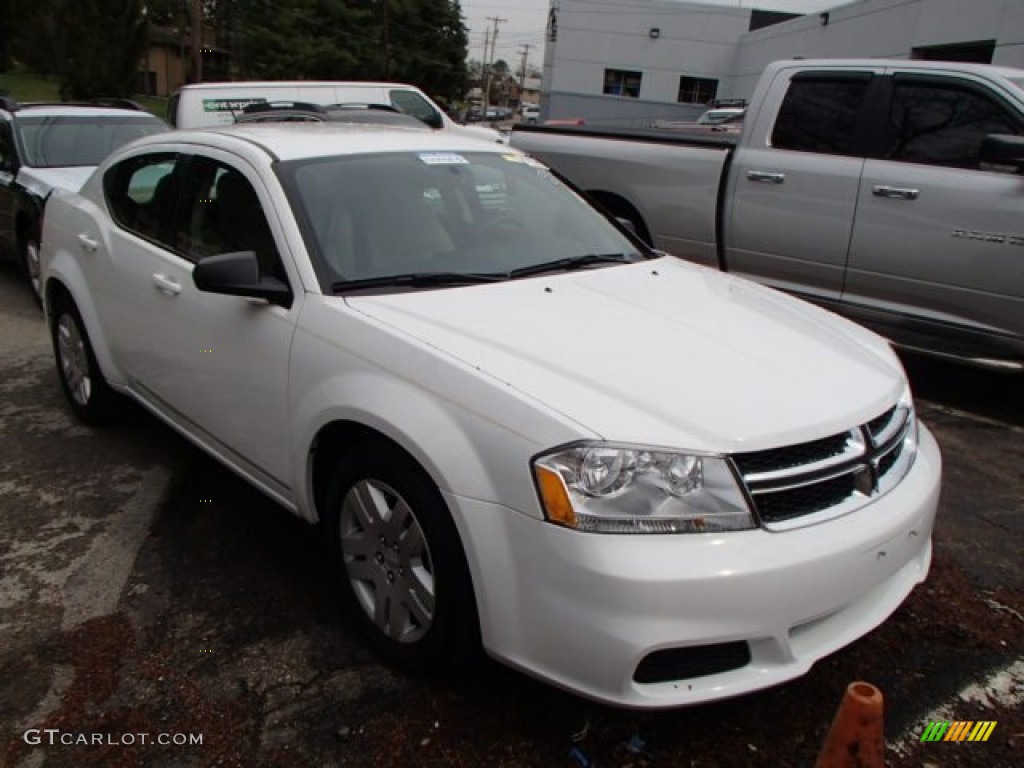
<box><xmin>511</xmin><ymin>59</ymin><xmax>1024</xmax><ymax>371</ymax></box>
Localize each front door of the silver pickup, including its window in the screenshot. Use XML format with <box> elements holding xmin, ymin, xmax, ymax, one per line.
<box><xmin>843</xmin><ymin>73</ymin><xmax>1024</xmax><ymax>355</ymax></box>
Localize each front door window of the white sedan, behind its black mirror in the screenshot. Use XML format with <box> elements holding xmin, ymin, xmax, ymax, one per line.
<box><xmin>175</xmin><ymin>156</ymin><xmax>286</xmax><ymax>280</ymax></box>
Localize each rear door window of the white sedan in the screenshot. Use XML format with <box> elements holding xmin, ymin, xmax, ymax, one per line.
<box><xmin>103</xmin><ymin>153</ymin><xmax>181</xmax><ymax>248</ymax></box>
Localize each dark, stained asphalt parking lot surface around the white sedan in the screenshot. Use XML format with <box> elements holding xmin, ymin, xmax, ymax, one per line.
<box><xmin>0</xmin><ymin>266</ymin><xmax>1024</xmax><ymax>767</ymax></box>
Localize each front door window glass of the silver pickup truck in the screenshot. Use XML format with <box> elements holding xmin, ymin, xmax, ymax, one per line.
<box><xmin>882</xmin><ymin>79</ymin><xmax>1021</xmax><ymax>169</ymax></box>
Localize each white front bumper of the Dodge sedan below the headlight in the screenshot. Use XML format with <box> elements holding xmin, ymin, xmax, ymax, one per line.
<box><xmin>446</xmin><ymin>425</ymin><xmax>941</xmax><ymax>708</ymax></box>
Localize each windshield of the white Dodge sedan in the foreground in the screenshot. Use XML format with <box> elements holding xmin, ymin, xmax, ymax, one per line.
<box><xmin>281</xmin><ymin>152</ymin><xmax>645</xmax><ymax>292</ymax></box>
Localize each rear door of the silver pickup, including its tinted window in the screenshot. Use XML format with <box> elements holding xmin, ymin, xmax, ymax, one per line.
<box><xmin>724</xmin><ymin>68</ymin><xmax>882</xmax><ymax>304</ymax></box>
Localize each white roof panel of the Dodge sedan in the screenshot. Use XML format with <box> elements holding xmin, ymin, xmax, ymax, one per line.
<box><xmin>139</xmin><ymin>122</ymin><xmax>519</xmax><ymax>161</ymax></box>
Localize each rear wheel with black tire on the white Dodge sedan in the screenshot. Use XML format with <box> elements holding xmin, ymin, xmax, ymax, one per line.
<box><xmin>50</xmin><ymin>297</ymin><xmax>116</xmax><ymax>424</ymax></box>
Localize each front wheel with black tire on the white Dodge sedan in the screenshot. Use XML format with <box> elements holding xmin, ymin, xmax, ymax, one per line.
<box><xmin>323</xmin><ymin>439</ymin><xmax>479</xmax><ymax>674</ymax></box>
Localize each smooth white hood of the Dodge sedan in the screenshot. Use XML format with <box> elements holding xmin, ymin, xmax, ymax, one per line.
<box><xmin>347</xmin><ymin>257</ymin><xmax>905</xmax><ymax>453</ymax></box>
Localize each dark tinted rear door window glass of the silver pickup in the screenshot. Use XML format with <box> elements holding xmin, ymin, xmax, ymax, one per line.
<box><xmin>771</xmin><ymin>74</ymin><xmax>870</xmax><ymax>155</ymax></box>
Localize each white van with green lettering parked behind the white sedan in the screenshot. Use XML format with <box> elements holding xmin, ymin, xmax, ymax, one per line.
<box><xmin>167</xmin><ymin>80</ymin><xmax>503</xmax><ymax>141</ymax></box>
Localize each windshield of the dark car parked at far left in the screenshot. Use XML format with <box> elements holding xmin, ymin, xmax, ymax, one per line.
<box><xmin>17</xmin><ymin>114</ymin><xmax>168</xmax><ymax>168</ymax></box>
